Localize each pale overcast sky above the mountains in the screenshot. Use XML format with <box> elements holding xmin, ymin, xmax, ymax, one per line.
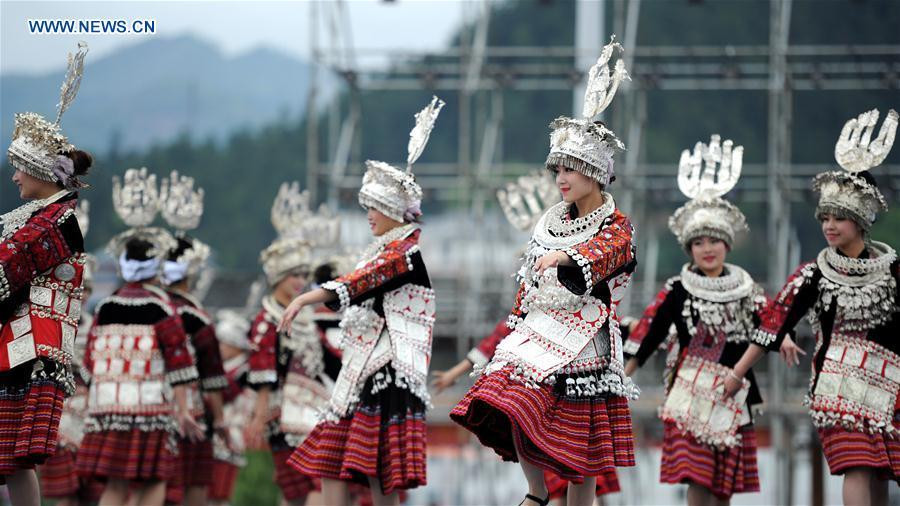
<box><xmin>0</xmin><ymin>0</ymin><xmax>478</xmax><ymax>74</ymax></box>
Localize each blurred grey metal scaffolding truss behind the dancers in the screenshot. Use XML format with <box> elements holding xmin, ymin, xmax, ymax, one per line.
<box><xmin>307</xmin><ymin>0</ymin><xmax>900</xmax><ymax>504</ymax></box>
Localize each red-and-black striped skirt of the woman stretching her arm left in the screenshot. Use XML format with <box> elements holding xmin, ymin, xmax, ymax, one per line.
<box><xmin>288</xmin><ymin>365</ymin><xmax>426</xmax><ymax>495</ymax></box>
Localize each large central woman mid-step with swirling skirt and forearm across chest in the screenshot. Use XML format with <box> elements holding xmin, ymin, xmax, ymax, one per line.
<box><xmin>450</xmin><ymin>43</ymin><xmax>638</xmax><ymax>505</ymax></box>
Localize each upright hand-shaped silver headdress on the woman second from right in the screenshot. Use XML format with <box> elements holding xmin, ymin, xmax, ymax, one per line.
<box><xmin>669</xmin><ymin>135</ymin><xmax>748</xmax><ymax>249</ymax></box>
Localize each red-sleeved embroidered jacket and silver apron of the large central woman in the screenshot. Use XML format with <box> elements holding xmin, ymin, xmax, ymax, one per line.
<box><xmin>485</xmin><ymin>204</ymin><xmax>639</xmax><ymax>398</ymax></box>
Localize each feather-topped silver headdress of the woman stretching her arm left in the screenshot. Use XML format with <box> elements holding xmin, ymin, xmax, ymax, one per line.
<box><xmin>359</xmin><ymin>97</ymin><xmax>444</xmax><ymax>222</ymax></box>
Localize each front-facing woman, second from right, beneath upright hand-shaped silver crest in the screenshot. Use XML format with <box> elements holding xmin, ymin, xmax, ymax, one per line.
<box><xmin>625</xmin><ymin>135</ymin><xmax>766</xmax><ymax>506</ymax></box>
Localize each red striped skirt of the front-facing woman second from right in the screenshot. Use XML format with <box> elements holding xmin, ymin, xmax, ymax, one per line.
<box><xmin>659</xmin><ymin>422</ymin><xmax>759</xmax><ymax>499</ymax></box>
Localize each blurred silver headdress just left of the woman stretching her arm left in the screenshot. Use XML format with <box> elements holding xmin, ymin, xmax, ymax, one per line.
<box><xmin>259</xmin><ymin>181</ymin><xmax>312</xmax><ymax>286</ymax></box>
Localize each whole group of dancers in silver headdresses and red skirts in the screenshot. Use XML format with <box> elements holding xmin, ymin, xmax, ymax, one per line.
<box><xmin>0</xmin><ymin>36</ymin><xmax>900</xmax><ymax>506</ymax></box>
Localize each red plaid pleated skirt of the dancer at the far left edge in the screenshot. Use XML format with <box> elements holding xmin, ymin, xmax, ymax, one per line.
<box><xmin>0</xmin><ymin>379</ymin><xmax>66</xmax><ymax>476</ymax></box>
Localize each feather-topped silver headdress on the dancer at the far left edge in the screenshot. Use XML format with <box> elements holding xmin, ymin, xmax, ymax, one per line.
<box><xmin>7</xmin><ymin>42</ymin><xmax>88</xmax><ymax>189</ymax></box>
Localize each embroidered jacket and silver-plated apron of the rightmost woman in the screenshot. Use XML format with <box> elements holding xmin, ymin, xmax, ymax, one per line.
<box><xmin>753</xmin><ymin>247</ymin><xmax>900</xmax><ymax>434</ymax></box>
